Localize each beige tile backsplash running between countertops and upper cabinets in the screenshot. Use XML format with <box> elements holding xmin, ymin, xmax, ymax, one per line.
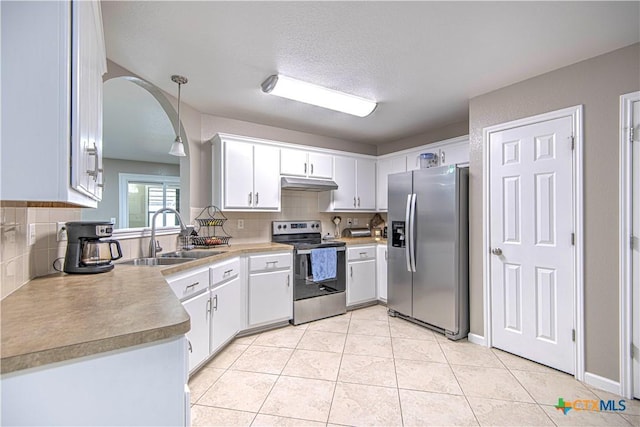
<box><xmin>0</xmin><ymin>190</ymin><xmax>386</xmax><ymax>299</ymax></box>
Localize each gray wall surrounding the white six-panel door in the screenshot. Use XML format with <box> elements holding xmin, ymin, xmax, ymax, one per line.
<box><xmin>469</xmin><ymin>44</ymin><xmax>640</xmax><ymax>381</ymax></box>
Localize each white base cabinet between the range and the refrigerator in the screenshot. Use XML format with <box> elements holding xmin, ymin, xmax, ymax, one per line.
<box><xmin>347</xmin><ymin>246</ymin><xmax>376</xmax><ymax>306</ymax></box>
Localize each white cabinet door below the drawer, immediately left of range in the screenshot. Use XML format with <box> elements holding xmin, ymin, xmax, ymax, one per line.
<box><xmin>249</xmin><ymin>270</ymin><xmax>293</xmax><ymax>326</ymax></box>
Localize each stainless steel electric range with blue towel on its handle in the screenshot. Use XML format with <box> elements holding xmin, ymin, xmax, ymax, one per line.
<box><xmin>271</xmin><ymin>221</ymin><xmax>347</xmax><ymax>325</ymax></box>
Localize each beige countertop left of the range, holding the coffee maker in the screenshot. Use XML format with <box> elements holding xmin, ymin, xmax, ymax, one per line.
<box><xmin>0</xmin><ymin>243</ymin><xmax>292</xmax><ymax>374</ymax></box>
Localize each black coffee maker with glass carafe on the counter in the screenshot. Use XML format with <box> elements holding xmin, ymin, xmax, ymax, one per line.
<box><xmin>63</xmin><ymin>221</ymin><xmax>122</xmax><ymax>274</ymax></box>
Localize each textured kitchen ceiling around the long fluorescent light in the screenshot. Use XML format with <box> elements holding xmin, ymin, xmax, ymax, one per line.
<box><xmin>102</xmin><ymin>1</ymin><xmax>640</xmax><ymax>144</ymax></box>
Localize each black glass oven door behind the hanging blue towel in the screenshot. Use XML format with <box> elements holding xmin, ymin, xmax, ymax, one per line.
<box><xmin>293</xmin><ymin>246</ymin><xmax>347</xmax><ymax>301</ymax></box>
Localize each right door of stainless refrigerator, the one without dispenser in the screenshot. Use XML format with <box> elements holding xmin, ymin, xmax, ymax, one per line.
<box><xmin>412</xmin><ymin>167</ymin><xmax>459</xmax><ymax>332</ymax></box>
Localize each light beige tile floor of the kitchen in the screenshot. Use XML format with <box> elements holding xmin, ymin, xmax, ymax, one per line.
<box><xmin>189</xmin><ymin>305</ymin><xmax>640</xmax><ymax>426</ymax></box>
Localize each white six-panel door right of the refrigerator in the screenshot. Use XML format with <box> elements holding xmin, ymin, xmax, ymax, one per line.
<box><xmin>489</xmin><ymin>117</ymin><xmax>575</xmax><ymax>373</ymax></box>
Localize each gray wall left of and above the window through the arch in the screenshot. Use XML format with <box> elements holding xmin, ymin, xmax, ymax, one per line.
<box><xmin>82</xmin><ymin>159</ymin><xmax>180</xmax><ymax>228</ymax></box>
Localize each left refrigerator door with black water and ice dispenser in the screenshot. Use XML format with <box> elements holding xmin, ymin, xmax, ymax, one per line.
<box><xmin>387</xmin><ymin>172</ymin><xmax>413</xmax><ymax>316</ymax></box>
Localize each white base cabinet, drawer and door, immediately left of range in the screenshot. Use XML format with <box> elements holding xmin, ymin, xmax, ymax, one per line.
<box><xmin>248</xmin><ymin>252</ymin><xmax>293</xmax><ymax>328</ymax></box>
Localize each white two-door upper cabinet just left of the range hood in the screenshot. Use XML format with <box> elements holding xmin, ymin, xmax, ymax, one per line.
<box><xmin>211</xmin><ymin>135</ymin><xmax>280</xmax><ymax>211</ymax></box>
